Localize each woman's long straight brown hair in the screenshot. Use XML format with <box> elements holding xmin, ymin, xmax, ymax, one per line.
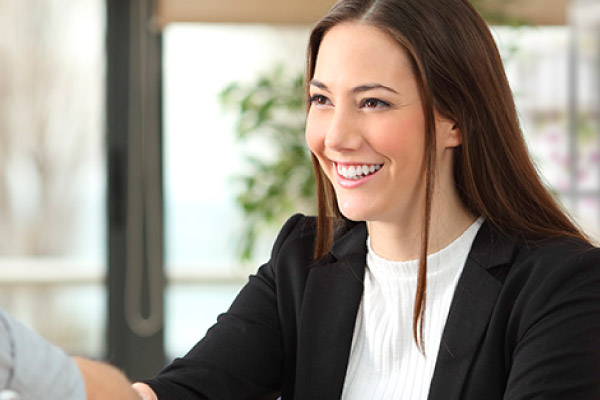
<box><xmin>306</xmin><ymin>0</ymin><xmax>588</xmax><ymax>350</ymax></box>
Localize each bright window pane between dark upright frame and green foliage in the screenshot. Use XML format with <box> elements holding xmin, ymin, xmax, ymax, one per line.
<box><xmin>164</xmin><ymin>23</ymin><xmax>309</xmax><ymax>357</ymax></box>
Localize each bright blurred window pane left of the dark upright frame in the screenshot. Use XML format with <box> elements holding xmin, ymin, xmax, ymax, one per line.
<box><xmin>0</xmin><ymin>0</ymin><xmax>105</xmax><ymax>356</ymax></box>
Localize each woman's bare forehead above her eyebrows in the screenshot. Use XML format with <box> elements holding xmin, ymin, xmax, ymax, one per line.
<box><xmin>314</xmin><ymin>22</ymin><xmax>413</xmax><ymax>84</ymax></box>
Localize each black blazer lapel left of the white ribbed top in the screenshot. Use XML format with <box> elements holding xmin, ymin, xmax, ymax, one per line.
<box><xmin>295</xmin><ymin>224</ymin><xmax>367</xmax><ymax>400</ymax></box>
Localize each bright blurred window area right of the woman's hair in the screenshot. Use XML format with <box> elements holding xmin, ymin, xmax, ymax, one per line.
<box><xmin>493</xmin><ymin>21</ymin><xmax>600</xmax><ymax>240</ymax></box>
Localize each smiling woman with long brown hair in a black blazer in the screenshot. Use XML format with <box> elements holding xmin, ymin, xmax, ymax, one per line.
<box><xmin>136</xmin><ymin>0</ymin><xmax>600</xmax><ymax>400</ymax></box>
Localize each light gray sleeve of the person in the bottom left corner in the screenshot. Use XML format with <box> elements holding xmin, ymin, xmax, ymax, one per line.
<box><xmin>0</xmin><ymin>310</ymin><xmax>86</xmax><ymax>400</ymax></box>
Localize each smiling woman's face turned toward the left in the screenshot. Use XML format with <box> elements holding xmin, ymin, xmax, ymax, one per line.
<box><xmin>306</xmin><ymin>23</ymin><xmax>458</xmax><ymax>223</ymax></box>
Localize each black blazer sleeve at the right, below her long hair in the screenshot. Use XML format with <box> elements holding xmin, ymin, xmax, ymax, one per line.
<box><xmin>504</xmin><ymin>250</ymin><xmax>600</xmax><ymax>400</ymax></box>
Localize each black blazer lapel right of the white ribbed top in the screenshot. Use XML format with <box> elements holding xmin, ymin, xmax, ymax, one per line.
<box><xmin>428</xmin><ymin>222</ymin><xmax>515</xmax><ymax>400</ymax></box>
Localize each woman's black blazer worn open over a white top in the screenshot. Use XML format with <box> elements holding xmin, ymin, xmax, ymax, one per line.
<box><xmin>147</xmin><ymin>215</ymin><xmax>600</xmax><ymax>400</ymax></box>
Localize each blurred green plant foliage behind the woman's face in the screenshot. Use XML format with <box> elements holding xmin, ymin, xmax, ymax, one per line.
<box><xmin>220</xmin><ymin>66</ymin><xmax>316</xmax><ymax>260</ymax></box>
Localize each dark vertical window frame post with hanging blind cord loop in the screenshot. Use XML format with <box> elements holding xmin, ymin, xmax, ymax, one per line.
<box><xmin>107</xmin><ymin>0</ymin><xmax>165</xmax><ymax>380</ymax></box>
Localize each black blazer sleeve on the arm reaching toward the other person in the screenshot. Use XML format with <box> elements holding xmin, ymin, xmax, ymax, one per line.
<box><xmin>146</xmin><ymin>215</ymin><xmax>303</xmax><ymax>400</ymax></box>
